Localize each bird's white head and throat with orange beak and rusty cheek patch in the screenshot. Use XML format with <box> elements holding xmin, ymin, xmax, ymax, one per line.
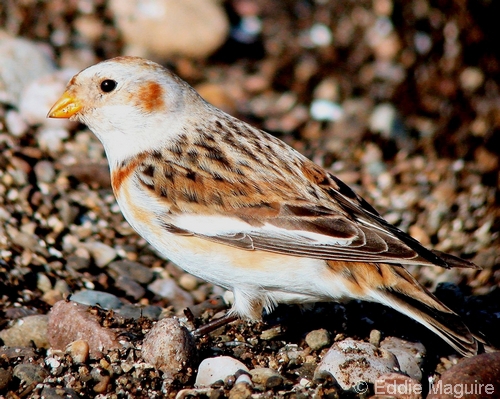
<box><xmin>48</xmin><ymin>57</ymin><xmax>206</xmax><ymax>166</ymax></box>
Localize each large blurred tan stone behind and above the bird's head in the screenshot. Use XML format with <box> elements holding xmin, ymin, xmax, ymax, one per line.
<box><xmin>109</xmin><ymin>0</ymin><xmax>229</xmax><ymax>59</ymax></box>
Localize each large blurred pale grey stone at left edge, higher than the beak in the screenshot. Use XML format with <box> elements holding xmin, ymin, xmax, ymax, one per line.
<box><xmin>0</xmin><ymin>31</ymin><xmax>55</xmax><ymax>108</ymax></box>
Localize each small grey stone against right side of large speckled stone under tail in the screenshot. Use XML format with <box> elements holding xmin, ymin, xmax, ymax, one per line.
<box><xmin>380</xmin><ymin>337</ymin><xmax>426</xmax><ymax>381</ymax></box>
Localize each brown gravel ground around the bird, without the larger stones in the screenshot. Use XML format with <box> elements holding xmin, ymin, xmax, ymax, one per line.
<box><xmin>0</xmin><ymin>0</ymin><xmax>500</xmax><ymax>398</ymax></box>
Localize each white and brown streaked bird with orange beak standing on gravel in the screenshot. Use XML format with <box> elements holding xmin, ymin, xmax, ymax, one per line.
<box><xmin>47</xmin><ymin>56</ymin><xmax>484</xmax><ymax>356</ymax></box>
